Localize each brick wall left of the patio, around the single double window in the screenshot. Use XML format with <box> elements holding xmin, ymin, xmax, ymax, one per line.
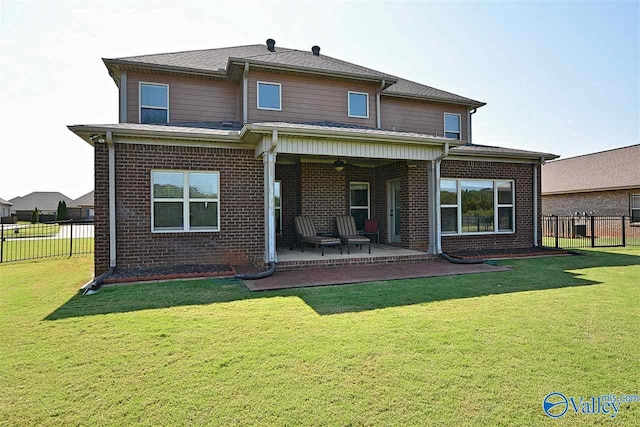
<box><xmin>95</xmin><ymin>144</ymin><xmax>264</xmax><ymax>274</ymax></box>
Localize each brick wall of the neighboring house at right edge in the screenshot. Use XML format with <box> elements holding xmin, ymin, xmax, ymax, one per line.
<box><xmin>542</xmin><ymin>188</ymin><xmax>640</xmax><ymax>216</ymax></box>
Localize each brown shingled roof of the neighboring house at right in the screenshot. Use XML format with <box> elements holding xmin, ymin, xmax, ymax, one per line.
<box><xmin>542</xmin><ymin>144</ymin><xmax>640</xmax><ymax>194</ymax></box>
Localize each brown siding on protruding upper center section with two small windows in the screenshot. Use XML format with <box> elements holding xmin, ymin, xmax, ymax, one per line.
<box><xmin>248</xmin><ymin>71</ymin><xmax>377</xmax><ymax>128</ymax></box>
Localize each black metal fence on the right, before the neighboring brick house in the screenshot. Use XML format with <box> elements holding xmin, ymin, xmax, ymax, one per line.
<box><xmin>542</xmin><ymin>215</ymin><xmax>640</xmax><ymax>249</ymax></box>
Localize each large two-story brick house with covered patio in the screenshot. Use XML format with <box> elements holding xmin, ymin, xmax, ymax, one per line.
<box><xmin>69</xmin><ymin>40</ymin><xmax>557</xmax><ymax>274</ymax></box>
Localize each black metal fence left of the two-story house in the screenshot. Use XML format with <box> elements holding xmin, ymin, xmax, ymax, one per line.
<box><xmin>0</xmin><ymin>220</ymin><xmax>93</xmax><ymax>263</ymax></box>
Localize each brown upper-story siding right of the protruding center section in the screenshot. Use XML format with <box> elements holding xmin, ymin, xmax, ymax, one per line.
<box><xmin>380</xmin><ymin>96</ymin><xmax>467</xmax><ymax>140</ymax></box>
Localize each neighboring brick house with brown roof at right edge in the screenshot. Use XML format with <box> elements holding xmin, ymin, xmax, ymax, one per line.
<box><xmin>542</xmin><ymin>144</ymin><xmax>640</xmax><ymax>223</ymax></box>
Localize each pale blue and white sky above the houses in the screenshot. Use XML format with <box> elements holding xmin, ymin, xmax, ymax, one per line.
<box><xmin>0</xmin><ymin>0</ymin><xmax>640</xmax><ymax>199</ymax></box>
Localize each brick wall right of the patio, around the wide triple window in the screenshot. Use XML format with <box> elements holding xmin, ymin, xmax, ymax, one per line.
<box><xmin>440</xmin><ymin>160</ymin><xmax>542</xmax><ymax>252</ymax></box>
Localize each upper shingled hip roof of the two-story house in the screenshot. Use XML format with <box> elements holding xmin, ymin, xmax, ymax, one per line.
<box><xmin>103</xmin><ymin>44</ymin><xmax>485</xmax><ymax>107</ymax></box>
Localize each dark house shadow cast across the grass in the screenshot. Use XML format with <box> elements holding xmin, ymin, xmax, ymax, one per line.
<box><xmin>44</xmin><ymin>252</ymin><xmax>640</xmax><ymax>320</ymax></box>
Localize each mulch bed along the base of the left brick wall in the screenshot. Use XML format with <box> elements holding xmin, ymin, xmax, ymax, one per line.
<box><xmin>104</xmin><ymin>264</ymin><xmax>236</xmax><ymax>284</ymax></box>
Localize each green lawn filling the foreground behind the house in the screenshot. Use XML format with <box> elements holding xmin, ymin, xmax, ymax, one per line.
<box><xmin>0</xmin><ymin>249</ymin><xmax>640</xmax><ymax>426</ymax></box>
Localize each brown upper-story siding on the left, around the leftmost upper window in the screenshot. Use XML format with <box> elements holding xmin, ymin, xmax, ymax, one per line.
<box><xmin>127</xmin><ymin>73</ymin><xmax>242</xmax><ymax>123</ymax></box>
